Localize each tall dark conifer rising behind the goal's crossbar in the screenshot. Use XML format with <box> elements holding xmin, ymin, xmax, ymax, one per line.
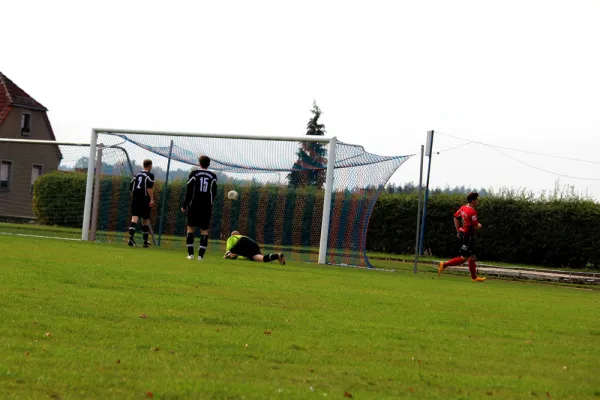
<box><xmin>287</xmin><ymin>101</ymin><xmax>327</xmax><ymax>189</ymax></box>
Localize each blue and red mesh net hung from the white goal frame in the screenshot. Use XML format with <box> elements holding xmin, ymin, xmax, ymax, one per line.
<box><xmin>0</xmin><ymin>130</ymin><xmax>409</xmax><ymax>267</ymax></box>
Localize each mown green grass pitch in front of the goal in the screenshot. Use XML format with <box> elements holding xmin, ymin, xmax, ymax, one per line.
<box><xmin>0</xmin><ymin>235</ymin><xmax>600</xmax><ymax>399</ymax></box>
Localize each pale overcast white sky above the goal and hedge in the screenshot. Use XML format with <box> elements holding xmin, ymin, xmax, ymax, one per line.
<box><xmin>0</xmin><ymin>0</ymin><xmax>600</xmax><ymax>200</ymax></box>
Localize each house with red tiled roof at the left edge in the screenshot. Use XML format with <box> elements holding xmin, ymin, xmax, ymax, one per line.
<box><xmin>0</xmin><ymin>72</ymin><xmax>62</xmax><ymax>218</ymax></box>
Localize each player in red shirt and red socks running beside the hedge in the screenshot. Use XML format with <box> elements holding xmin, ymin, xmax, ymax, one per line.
<box><xmin>438</xmin><ymin>192</ymin><xmax>485</xmax><ymax>282</ymax></box>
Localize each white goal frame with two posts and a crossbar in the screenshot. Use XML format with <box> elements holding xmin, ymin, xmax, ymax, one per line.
<box><xmin>81</xmin><ymin>128</ymin><xmax>337</xmax><ymax>264</ymax></box>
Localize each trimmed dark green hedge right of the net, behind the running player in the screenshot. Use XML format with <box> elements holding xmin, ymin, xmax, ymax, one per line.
<box><xmin>367</xmin><ymin>194</ymin><xmax>600</xmax><ymax>268</ymax></box>
